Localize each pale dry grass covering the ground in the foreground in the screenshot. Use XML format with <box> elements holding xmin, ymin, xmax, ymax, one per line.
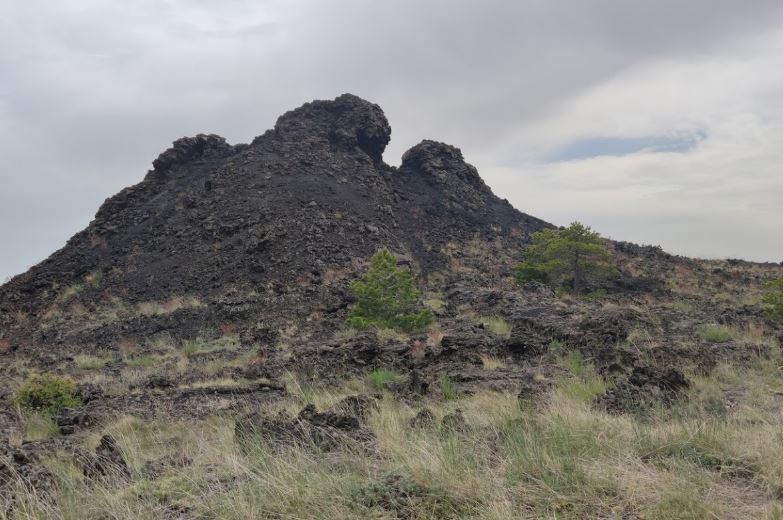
<box><xmin>0</xmin><ymin>352</ymin><xmax>783</xmax><ymax>520</ymax></box>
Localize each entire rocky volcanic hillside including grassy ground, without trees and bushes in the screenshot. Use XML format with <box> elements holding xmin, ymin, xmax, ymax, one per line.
<box><xmin>0</xmin><ymin>94</ymin><xmax>783</xmax><ymax>519</ymax></box>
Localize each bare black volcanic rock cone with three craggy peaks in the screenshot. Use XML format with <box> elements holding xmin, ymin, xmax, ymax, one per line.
<box><xmin>0</xmin><ymin>94</ymin><xmax>547</xmax><ymax>352</ymax></box>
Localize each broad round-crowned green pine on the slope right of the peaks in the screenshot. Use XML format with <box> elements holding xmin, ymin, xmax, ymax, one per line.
<box><xmin>515</xmin><ymin>222</ymin><xmax>616</xmax><ymax>294</ymax></box>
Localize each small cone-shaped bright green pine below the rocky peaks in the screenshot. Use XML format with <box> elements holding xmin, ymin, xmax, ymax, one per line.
<box><xmin>346</xmin><ymin>248</ymin><xmax>434</xmax><ymax>332</ymax></box>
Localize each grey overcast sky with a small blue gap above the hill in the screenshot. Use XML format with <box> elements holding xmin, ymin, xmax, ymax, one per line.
<box><xmin>0</xmin><ymin>0</ymin><xmax>783</xmax><ymax>282</ymax></box>
